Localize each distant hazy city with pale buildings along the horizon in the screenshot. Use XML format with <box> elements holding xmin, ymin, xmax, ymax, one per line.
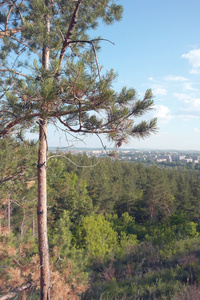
<box><xmin>49</xmin><ymin>148</ymin><xmax>200</xmax><ymax>164</ymax></box>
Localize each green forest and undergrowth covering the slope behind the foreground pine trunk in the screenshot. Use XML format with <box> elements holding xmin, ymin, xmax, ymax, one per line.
<box><xmin>0</xmin><ymin>139</ymin><xmax>200</xmax><ymax>299</ymax></box>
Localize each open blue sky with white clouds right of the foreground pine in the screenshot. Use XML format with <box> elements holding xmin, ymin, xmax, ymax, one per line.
<box><xmin>49</xmin><ymin>0</ymin><xmax>200</xmax><ymax>150</ymax></box>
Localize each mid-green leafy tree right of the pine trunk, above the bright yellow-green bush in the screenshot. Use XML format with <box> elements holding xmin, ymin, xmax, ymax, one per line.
<box><xmin>48</xmin><ymin>158</ymin><xmax>94</xmax><ymax>224</ymax></box>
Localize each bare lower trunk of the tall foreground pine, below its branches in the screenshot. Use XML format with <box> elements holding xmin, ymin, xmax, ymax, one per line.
<box><xmin>37</xmin><ymin>119</ymin><xmax>50</xmax><ymax>300</ymax></box>
